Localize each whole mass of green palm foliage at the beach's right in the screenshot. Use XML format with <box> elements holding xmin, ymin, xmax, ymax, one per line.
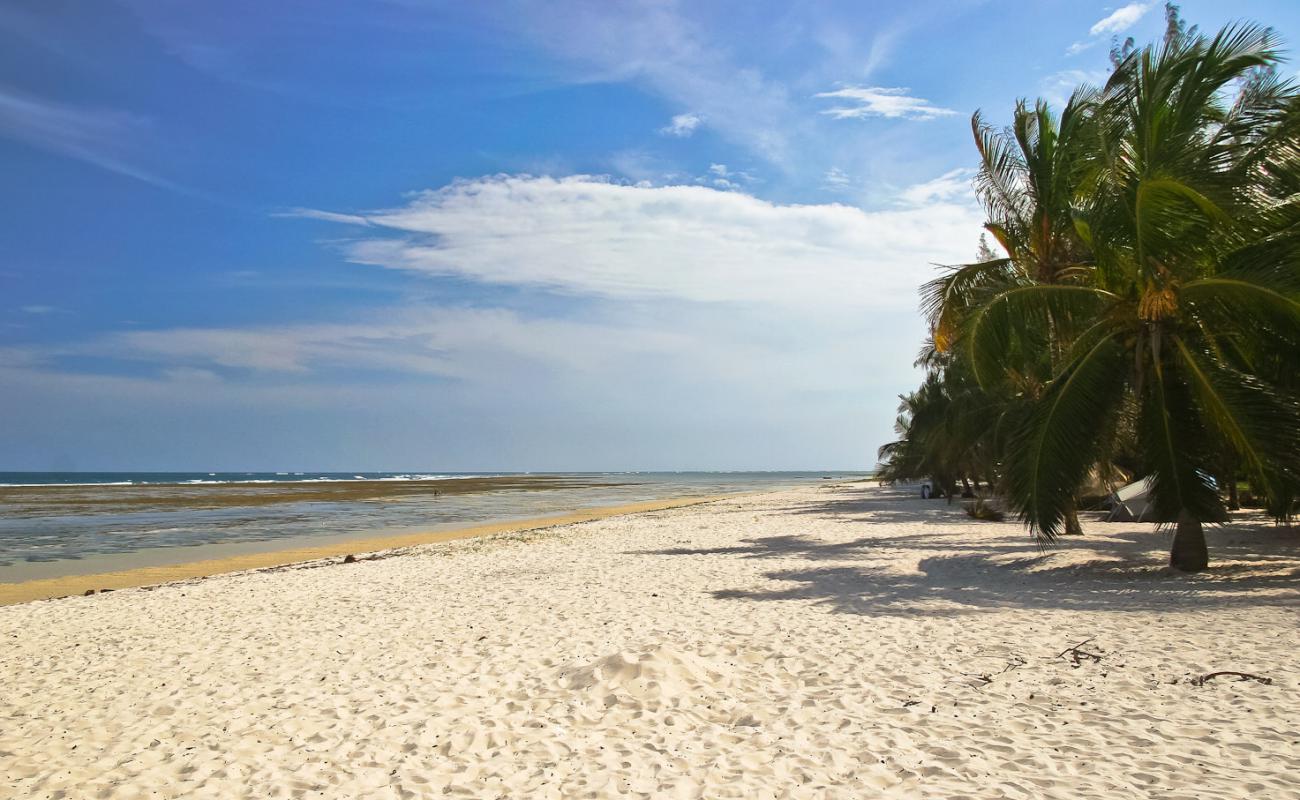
<box><xmin>883</xmin><ymin>14</ymin><xmax>1300</xmax><ymax>564</ymax></box>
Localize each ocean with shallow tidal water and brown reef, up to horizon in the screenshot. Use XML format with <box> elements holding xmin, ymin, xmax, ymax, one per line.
<box><xmin>0</xmin><ymin>471</ymin><xmax>870</xmax><ymax>583</ymax></box>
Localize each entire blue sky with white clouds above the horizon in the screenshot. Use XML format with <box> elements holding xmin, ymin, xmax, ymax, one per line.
<box><xmin>0</xmin><ymin>0</ymin><xmax>1300</xmax><ymax>471</ymax></box>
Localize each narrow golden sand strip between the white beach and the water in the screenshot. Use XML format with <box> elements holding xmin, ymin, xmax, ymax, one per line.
<box><xmin>0</xmin><ymin>494</ymin><xmax>736</xmax><ymax>606</ymax></box>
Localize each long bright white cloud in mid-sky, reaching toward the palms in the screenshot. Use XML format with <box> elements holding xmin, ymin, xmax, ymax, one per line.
<box><xmin>299</xmin><ymin>175</ymin><xmax>979</xmax><ymax>310</ymax></box>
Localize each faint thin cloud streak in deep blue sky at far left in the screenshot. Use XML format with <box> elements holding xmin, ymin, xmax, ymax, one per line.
<box><xmin>0</xmin><ymin>86</ymin><xmax>179</xmax><ymax>189</ymax></box>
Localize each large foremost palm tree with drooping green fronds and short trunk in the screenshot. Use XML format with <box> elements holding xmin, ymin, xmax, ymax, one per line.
<box><xmin>958</xmin><ymin>26</ymin><xmax>1300</xmax><ymax>570</ymax></box>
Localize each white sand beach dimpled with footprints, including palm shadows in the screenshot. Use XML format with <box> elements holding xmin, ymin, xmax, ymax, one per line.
<box><xmin>0</xmin><ymin>484</ymin><xmax>1300</xmax><ymax>800</ymax></box>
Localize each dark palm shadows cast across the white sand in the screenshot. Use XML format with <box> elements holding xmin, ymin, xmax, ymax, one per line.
<box><xmin>624</xmin><ymin>496</ymin><xmax>1300</xmax><ymax>615</ymax></box>
